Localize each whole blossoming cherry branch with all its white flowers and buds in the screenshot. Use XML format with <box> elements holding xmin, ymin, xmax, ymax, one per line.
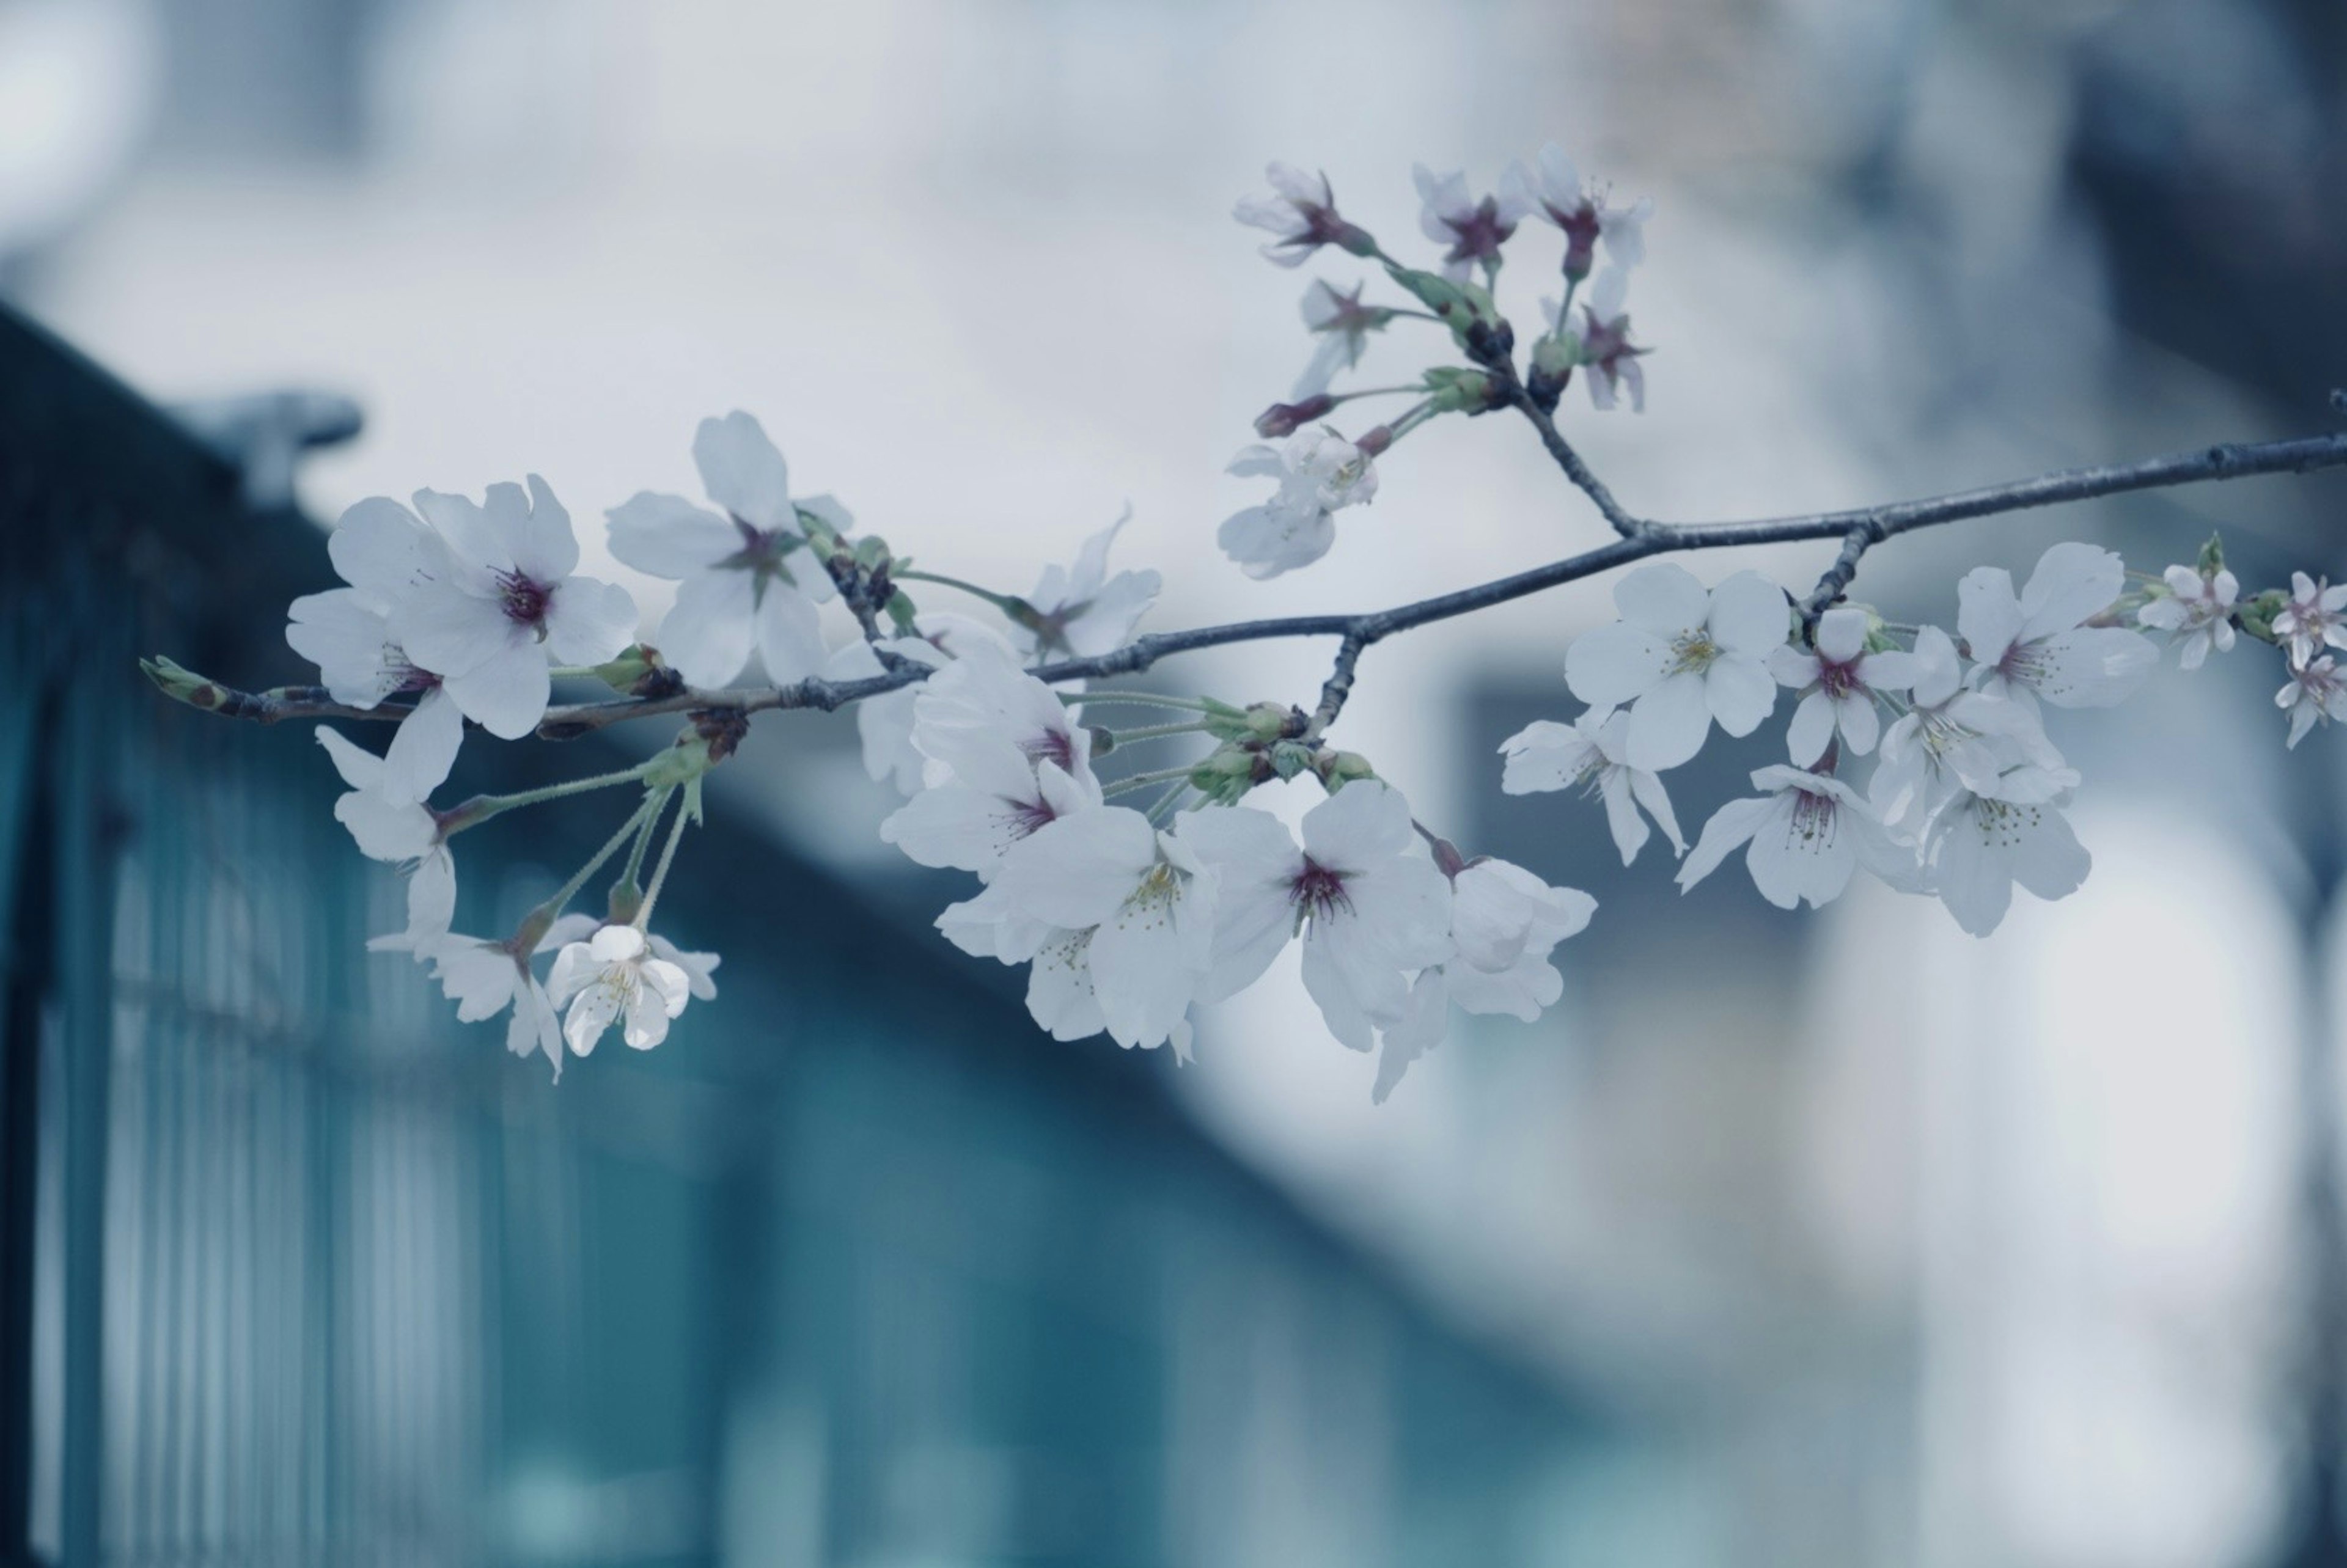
<box><xmin>148</xmin><ymin>145</ymin><xmax>2347</xmax><ymax>1099</ymax></box>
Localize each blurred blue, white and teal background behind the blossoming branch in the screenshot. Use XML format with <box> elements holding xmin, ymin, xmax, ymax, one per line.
<box><xmin>0</xmin><ymin>0</ymin><xmax>2347</xmax><ymax>1568</ymax></box>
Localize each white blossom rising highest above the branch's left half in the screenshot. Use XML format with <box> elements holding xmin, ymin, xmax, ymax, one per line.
<box><xmin>606</xmin><ymin>411</ymin><xmax>850</xmax><ymax>688</ymax></box>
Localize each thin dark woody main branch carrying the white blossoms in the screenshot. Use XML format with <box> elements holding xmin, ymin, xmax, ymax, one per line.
<box><xmin>167</xmin><ymin>432</ymin><xmax>2347</xmax><ymax>739</ymax></box>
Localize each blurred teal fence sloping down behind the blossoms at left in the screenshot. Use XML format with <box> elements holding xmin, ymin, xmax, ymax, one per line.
<box><xmin>0</xmin><ymin>300</ymin><xmax>1603</xmax><ymax>1566</ymax></box>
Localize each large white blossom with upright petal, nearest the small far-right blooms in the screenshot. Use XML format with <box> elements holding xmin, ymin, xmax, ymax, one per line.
<box><xmin>1955</xmin><ymin>544</ymin><xmax>2159</xmax><ymax>709</ymax></box>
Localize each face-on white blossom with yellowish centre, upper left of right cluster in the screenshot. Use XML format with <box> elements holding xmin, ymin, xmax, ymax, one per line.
<box><xmin>1565</xmin><ymin>561</ymin><xmax>1788</xmax><ymax>772</ymax></box>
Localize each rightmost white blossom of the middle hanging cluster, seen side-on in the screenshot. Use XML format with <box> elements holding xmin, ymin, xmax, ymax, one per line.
<box><xmin>1371</xmin><ymin>859</ymin><xmax>1598</xmax><ymax>1103</ymax></box>
